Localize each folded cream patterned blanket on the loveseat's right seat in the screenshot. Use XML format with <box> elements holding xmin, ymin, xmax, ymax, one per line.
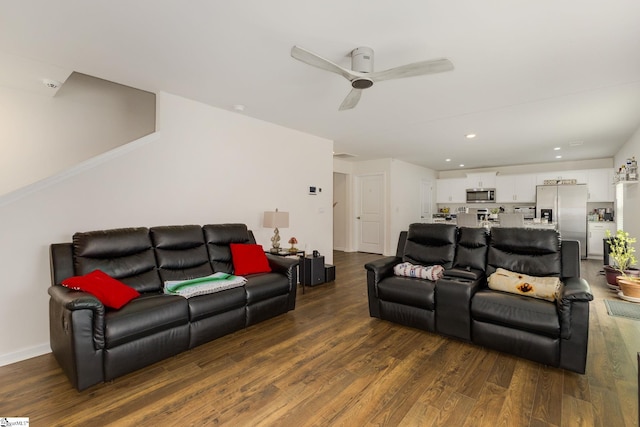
<box><xmin>487</xmin><ymin>268</ymin><xmax>561</xmax><ymax>301</ymax></box>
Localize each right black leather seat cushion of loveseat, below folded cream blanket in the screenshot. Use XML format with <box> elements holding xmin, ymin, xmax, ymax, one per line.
<box><xmin>471</xmin><ymin>289</ymin><xmax>560</xmax><ymax>338</ymax></box>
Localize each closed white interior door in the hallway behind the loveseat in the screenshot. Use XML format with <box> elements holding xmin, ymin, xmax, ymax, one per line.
<box><xmin>357</xmin><ymin>175</ymin><xmax>384</xmax><ymax>254</ymax></box>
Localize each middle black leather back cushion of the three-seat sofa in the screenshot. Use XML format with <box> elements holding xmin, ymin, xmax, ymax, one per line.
<box><xmin>149</xmin><ymin>225</ymin><xmax>213</xmax><ymax>282</ymax></box>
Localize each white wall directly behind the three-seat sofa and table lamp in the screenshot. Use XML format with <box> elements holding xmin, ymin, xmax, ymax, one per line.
<box><xmin>0</xmin><ymin>94</ymin><xmax>333</xmax><ymax>365</ymax></box>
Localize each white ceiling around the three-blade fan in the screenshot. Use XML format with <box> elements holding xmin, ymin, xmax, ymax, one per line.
<box><xmin>0</xmin><ymin>0</ymin><xmax>640</xmax><ymax>171</ymax></box>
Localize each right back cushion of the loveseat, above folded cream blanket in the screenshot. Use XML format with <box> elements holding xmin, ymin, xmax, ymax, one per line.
<box><xmin>486</xmin><ymin>227</ymin><xmax>562</xmax><ymax>277</ymax></box>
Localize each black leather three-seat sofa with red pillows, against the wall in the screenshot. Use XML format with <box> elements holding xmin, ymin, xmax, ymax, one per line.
<box><xmin>49</xmin><ymin>224</ymin><xmax>297</xmax><ymax>390</ymax></box>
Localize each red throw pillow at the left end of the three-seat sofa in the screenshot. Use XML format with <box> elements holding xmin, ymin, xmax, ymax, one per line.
<box><xmin>62</xmin><ymin>270</ymin><xmax>140</xmax><ymax>309</ymax></box>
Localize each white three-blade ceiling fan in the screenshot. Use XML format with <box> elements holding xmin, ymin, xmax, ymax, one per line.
<box><xmin>291</xmin><ymin>46</ymin><xmax>453</xmax><ymax>110</ymax></box>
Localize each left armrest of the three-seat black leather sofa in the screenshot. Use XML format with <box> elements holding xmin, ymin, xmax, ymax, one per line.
<box><xmin>49</xmin><ymin>286</ymin><xmax>105</xmax><ymax>390</ymax></box>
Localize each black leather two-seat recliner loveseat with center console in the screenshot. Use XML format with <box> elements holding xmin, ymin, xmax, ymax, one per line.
<box><xmin>365</xmin><ymin>224</ymin><xmax>593</xmax><ymax>374</ymax></box>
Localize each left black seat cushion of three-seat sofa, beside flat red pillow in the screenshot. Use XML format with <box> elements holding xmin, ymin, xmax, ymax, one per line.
<box><xmin>105</xmin><ymin>294</ymin><xmax>189</xmax><ymax>348</ymax></box>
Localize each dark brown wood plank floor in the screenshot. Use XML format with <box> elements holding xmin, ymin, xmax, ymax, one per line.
<box><xmin>0</xmin><ymin>252</ymin><xmax>640</xmax><ymax>426</ymax></box>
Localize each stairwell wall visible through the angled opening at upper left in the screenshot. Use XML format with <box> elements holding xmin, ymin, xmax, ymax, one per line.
<box><xmin>0</xmin><ymin>73</ymin><xmax>155</xmax><ymax>195</ymax></box>
